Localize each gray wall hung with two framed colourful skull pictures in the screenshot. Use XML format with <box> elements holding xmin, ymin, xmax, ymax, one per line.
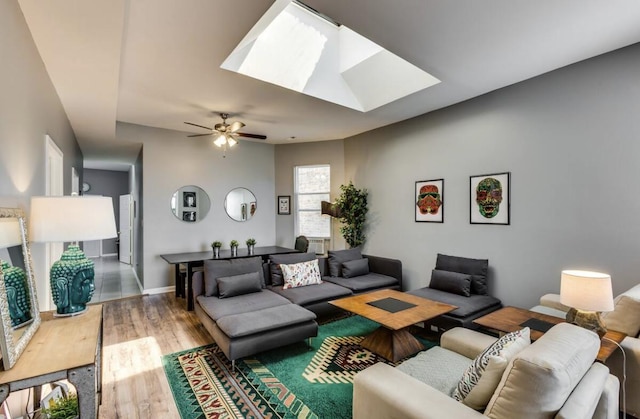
<box><xmin>345</xmin><ymin>45</ymin><xmax>640</xmax><ymax>307</ymax></box>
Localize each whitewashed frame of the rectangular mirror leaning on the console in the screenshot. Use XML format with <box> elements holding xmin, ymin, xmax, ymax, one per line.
<box><xmin>0</xmin><ymin>208</ymin><xmax>41</xmax><ymax>370</ymax></box>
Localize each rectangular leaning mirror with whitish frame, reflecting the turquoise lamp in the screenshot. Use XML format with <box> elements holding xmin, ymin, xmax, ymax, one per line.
<box><xmin>0</xmin><ymin>208</ymin><xmax>40</xmax><ymax>369</ymax></box>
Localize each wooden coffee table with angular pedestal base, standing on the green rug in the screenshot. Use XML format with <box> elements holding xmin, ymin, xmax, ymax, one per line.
<box><xmin>329</xmin><ymin>290</ymin><xmax>457</xmax><ymax>362</ymax></box>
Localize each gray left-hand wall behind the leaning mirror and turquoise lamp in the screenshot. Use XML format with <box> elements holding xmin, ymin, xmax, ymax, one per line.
<box><xmin>0</xmin><ymin>0</ymin><xmax>82</xmax><ymax>309</ymax></box>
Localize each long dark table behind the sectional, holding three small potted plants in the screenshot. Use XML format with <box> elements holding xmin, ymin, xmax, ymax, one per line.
<box><xmin>160</xmin><ymin>246</ymin><xmax>298</xmax><ymax>311</ymax></box>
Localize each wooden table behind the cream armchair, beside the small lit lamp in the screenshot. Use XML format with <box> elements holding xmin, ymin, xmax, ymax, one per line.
<box><xmin>473</xmin><ymin>307</ymin><xmax>627</xmax><ymax>362</ymax></box>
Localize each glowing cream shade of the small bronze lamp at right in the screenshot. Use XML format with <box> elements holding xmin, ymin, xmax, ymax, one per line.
<box><xmin>560</xmin><ymin>271</ymin><xmax>613</xmax><ymax>311</ymax></box>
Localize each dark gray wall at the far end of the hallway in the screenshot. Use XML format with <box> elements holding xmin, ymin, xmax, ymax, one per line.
<box><xmin>84</xmin><ymin>169</ymin><xmax>129</xmax><ymax>255</ymax></box>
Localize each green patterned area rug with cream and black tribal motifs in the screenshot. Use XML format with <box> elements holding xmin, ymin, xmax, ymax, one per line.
<box><xmin>162</xmin><ymin>316</ymin><xmax>433</xmax><ymax>419</ymax></box>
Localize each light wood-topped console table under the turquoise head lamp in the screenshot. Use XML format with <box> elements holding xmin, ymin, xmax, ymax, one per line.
<box><xmin>0</xmin><ymin>305</ymin><xmax>102</xmax><ymax>419</ymax></box>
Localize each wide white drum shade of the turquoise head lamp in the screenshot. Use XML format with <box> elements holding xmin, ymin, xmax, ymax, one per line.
<box><xmin>29</xmin><ymin>196</ymin><xmax>117</xmax><ymax>242</ymax></box>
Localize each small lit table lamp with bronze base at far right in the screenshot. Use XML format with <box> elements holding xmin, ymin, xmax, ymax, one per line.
<box><xmin>560</xmin><ymin>270</ymin><xmax>613</xmax><ymax>337</ymax></box>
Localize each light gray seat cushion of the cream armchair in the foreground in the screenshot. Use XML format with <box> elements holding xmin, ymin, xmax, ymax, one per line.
<box><xmin>396</xmin><ymin>346</ymin><xmax>472</xmax><ymax>397</ymax></box>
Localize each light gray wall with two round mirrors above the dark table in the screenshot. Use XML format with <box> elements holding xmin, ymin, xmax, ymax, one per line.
<box><xmin>117</xmin><ymin>123</ymin><xmax>276</xmax><ymax>292</ymax></box>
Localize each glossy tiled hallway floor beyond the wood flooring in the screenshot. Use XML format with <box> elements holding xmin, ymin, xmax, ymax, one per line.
<box><xmin>91</xmin><ymin>255</ymin><xmax>142</xmax><ymax>303</ymax></box>
